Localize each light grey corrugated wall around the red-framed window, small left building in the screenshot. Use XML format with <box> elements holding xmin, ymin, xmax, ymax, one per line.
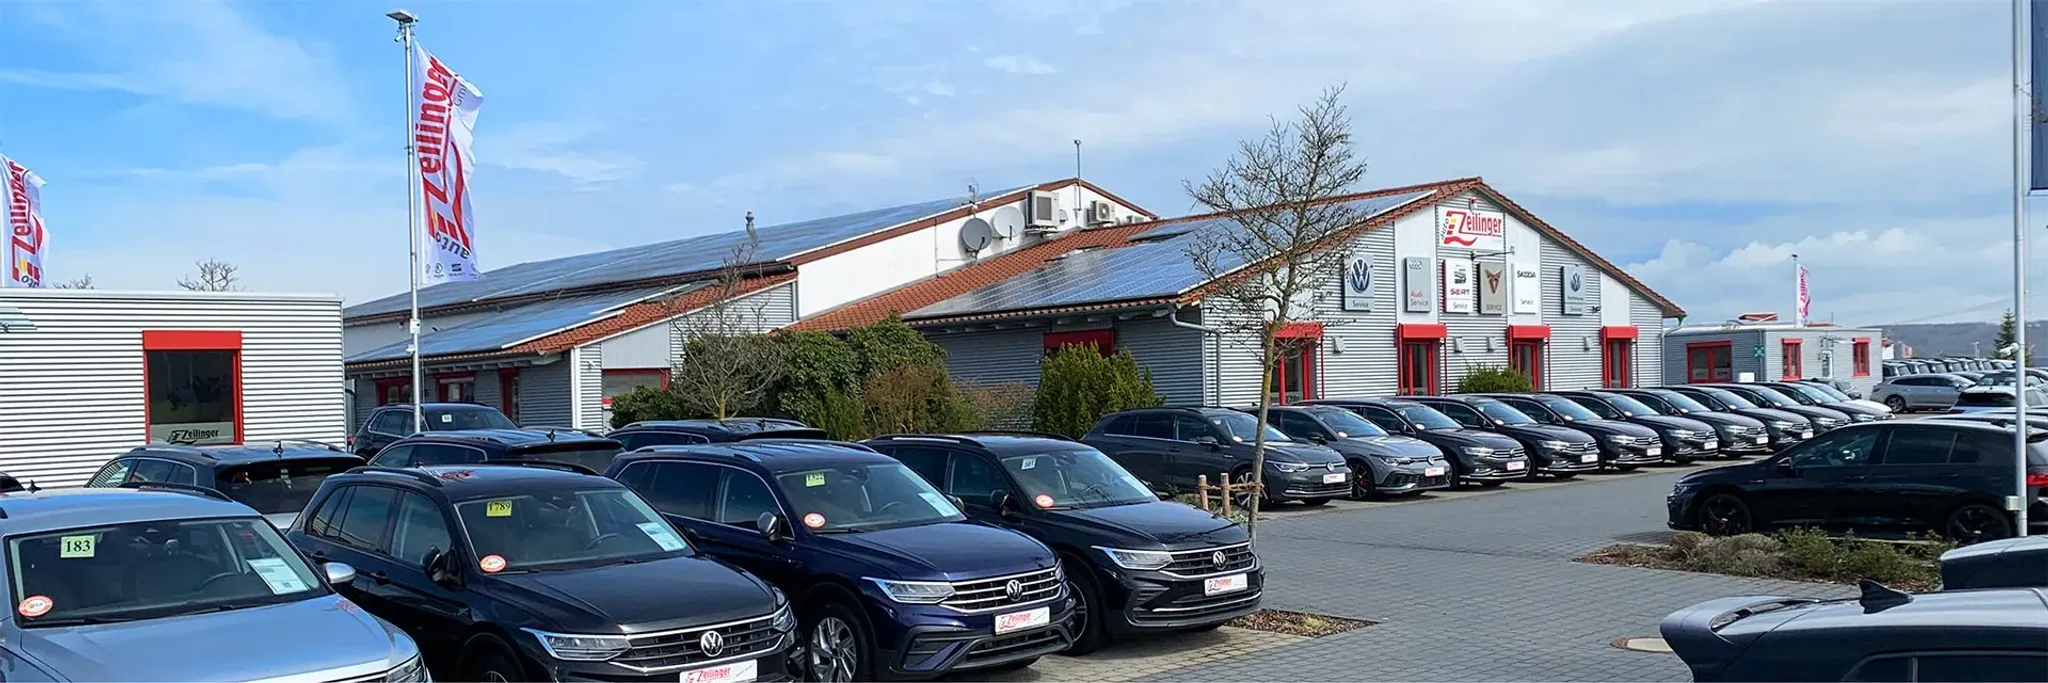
<box><xmin>0</xmin><ymin>289</ymin><xmax>346</xmax><ymax>486</ymax></box>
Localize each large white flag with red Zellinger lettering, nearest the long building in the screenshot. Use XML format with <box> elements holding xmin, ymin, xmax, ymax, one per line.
<box><xmin>412</xmin><ymin>43</ymin><xmax>483</xmax><ymax>285</ymax></box>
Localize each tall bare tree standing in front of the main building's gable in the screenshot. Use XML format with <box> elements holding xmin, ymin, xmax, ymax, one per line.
<box><xmin>1184</xmin><ymin>86</ymin><xmax>1366</xmax><ymax>533</ymax></box>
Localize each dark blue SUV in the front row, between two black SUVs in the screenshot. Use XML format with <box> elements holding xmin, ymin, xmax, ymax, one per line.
<box><xmin>606</xmin><ymin>439</ymin><xmax>1073</xmax><ymax>681</ymax></box>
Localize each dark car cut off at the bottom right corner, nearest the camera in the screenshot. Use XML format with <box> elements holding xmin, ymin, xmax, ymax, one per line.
<box><xmin>1659</xmin><ymin>580</ymin><xmax>2048</xmax><ymax>683</ymax></box>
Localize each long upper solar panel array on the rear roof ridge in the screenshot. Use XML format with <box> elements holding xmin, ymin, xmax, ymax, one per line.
<box><xmin>356</xmin><ymin>187</ymin><xmax>1022</xmax><ymax>318</ymax></box>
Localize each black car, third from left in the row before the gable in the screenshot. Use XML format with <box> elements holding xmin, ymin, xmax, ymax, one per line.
<box><xmin>1303</xmin><ymin>398</ymin><xmax>1530</xmax><ymax>486</ymax></box>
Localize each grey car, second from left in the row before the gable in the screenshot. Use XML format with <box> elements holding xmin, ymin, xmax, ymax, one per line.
<box><xmin>1268</xmin><ymin>406</ymin><xmax>1450</xmax><ymax>500</ymax></box>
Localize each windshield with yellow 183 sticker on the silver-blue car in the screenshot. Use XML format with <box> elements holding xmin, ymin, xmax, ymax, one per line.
<box><xmin>8</xmin><ymin>517</ymin><xmax>328</xmax><ymax>628</ymax></box>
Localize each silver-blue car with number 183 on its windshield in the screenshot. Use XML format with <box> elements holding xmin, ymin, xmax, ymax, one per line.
<box><xmin>0</xmin><ymin>484</ymin><xmax>428</xmax><ymax>681</ymax></box>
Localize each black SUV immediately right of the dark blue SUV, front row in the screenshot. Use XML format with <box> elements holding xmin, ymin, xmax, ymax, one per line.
<box><xmin>866</xmin><ymin>433</ymin><xmax>1264</xmax><ymax>654</ymax></box>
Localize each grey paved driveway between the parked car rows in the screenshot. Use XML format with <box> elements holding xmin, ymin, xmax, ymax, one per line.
<box><xmin>991</xmin><ymin>464</ymin><xmax>1875</xmax><ymax>681</ymax></box>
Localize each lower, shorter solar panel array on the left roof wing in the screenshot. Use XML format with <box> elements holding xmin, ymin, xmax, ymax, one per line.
<box><xmin>344</xmin><ymin>283</ymin><xmax>679</xmax><ymax>363</ymax></box>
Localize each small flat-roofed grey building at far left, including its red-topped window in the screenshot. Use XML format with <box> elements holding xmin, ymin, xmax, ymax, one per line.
<box><xmin>0</xmin><ymin>289</ymin><xmax>346</xmax><ymax>488</ymax></box>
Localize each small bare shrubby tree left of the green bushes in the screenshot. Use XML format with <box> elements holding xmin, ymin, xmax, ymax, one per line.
<box><xmin>668</xmin><ymin>213</ymin><xmax>784</xmax><ymax>420</ymax></box>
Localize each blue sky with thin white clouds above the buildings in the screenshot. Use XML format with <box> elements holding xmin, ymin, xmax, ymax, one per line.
<box><xmin>0</xmin><ymin>0</ymin><xmax>2023</xmax><ymax>322</ymax></box>
